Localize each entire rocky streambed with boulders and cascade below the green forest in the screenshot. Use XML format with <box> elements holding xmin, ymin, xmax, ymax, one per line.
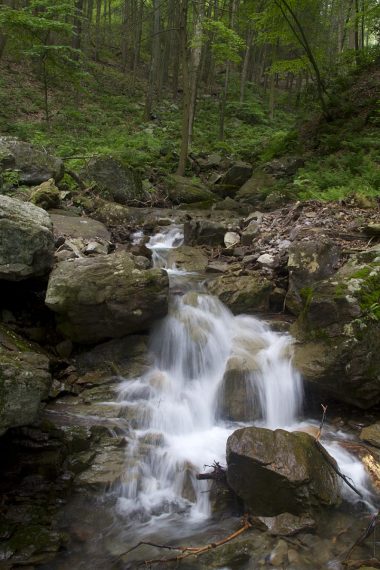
<box><xmin>0</xmin><ymin>139</ymin><xmax>380</xmax><ymax>569</ymax></box>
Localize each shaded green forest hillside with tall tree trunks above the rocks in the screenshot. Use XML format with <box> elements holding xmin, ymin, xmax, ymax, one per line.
<box><xmin>0</xmin><ymin>0</ymin><xmax>380</xmax><ymax>201</ymax></box>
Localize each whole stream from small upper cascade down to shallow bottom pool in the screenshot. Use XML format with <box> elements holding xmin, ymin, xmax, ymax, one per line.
<box><xmin>44</xmin><ymin>226</ymin><xmax>376</xmax><ymax>570</ymax></box>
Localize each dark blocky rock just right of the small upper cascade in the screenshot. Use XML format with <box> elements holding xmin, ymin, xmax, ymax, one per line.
<box><xmin>184</xmin><ymin>216</ymin><xmax>239</xmax><ymax>245</ymax></box>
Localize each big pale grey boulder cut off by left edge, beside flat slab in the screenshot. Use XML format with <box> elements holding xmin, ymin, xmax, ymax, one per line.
<box><xmin>0</xmin><ymin>196</ymin><xmax>54</xmax><ymax>281</ymax></box>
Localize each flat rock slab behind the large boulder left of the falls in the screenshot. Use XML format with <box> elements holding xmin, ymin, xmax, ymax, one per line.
<box><xmin>50</xmin><ymin>214</ymin><xmax>111</xmax><ymax>241</ymax></box>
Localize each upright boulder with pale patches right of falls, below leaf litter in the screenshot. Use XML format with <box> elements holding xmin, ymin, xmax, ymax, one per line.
<box><xmin>286</xmin><ymin>237</ymin><xmax>342</xmax><ymax>314</ymax></box>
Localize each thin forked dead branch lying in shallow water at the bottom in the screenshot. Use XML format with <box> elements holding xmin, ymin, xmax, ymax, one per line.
<box><xmin>118</xmin><ymin>515</ymin><xmax>252</xmax><ymax>566</ymax></box>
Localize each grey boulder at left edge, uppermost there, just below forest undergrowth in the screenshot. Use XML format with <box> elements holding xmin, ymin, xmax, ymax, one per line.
<box><xmin>0</xmin><ymin>137</ymin><xmax>64</xmax><ymax>186</ymax></box>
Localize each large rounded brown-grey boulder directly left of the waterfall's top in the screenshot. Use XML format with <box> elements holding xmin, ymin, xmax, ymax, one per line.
<box><xmin>45</xmin><ymin>252</ymin><xmax>169</xmax><ymax>344</ymax></box>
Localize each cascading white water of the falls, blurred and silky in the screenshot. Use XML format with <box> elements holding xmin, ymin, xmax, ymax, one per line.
<box><xmin>118</xmin><ymin>223</ymin><xmax>374</xmax><ymax>522</ymax></box>
